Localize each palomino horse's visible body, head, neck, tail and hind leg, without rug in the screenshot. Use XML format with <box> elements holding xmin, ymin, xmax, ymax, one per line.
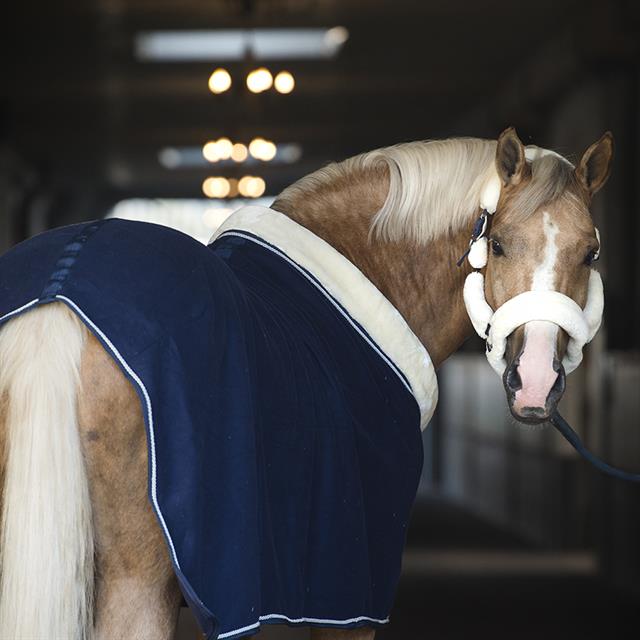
<box><xmin>0</xmin><ymin>129</ymin><xmax>612</xmax><ymax>640</ymax></box>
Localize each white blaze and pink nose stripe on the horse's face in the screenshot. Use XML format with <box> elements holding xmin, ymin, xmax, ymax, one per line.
<box><xmin>514</xmin><ymin>211</ymin><xmax>558</xmax><ymax>411</ymax></box>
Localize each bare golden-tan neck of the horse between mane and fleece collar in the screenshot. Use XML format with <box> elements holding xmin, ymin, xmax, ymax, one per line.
<box><xmin>273</xmin><ymin>162</ymin><xmax>472</xmax><ymax>368</ymax></box>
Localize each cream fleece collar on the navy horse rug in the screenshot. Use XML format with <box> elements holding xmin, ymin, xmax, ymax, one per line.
<box><xmin>209</xmin><ymin>206</ymin><xmax>438</xmax><ymax>429</ymax></box>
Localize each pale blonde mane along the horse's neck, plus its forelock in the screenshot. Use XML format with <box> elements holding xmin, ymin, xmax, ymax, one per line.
<box><xmin>274</xmin><ymin>138</ymin><xmax>573</xmax><ymax>244</ymax></box>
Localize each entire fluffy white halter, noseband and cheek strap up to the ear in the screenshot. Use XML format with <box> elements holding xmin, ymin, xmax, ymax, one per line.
<box><xmin>458</xmin><ymin>175</ymin><xmax>604</xmax><ymax>376</ymax></box>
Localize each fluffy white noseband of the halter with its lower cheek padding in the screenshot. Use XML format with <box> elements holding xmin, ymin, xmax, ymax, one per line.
<box><xmin>464</xmin><ymin>270</ymin><xmax>604</xmax><ymax>376</ymax></box>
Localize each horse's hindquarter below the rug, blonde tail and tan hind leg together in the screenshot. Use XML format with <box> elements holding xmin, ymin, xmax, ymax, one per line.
<box><xmin>0</xmin><ymin>303</ymin><xmax>375</xmax><ymax>640</ymax></box>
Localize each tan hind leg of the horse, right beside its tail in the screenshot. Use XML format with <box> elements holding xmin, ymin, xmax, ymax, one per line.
<box><xmin>78</xmin><ymin>336</ymin><xmax>181</xmax><ymax>640</ymax></box>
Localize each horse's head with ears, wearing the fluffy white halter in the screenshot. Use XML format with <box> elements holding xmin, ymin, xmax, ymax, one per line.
<box><xmin>465</xmin><ymin>128</ymin><xmax>613</xmax><ymax>423</ymax></box>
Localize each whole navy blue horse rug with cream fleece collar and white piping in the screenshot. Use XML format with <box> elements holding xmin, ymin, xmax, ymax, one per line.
<box><xmin>0</xmin><ymin>207</ymin><xmax>437</xmax><ymax>638</ymax></box>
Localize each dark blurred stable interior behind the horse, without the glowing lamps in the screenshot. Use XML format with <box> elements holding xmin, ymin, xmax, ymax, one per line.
<box><xmin>0</xmin><ymin>0</ymin><xmax>640</xmax><ymax>639</ymax></box>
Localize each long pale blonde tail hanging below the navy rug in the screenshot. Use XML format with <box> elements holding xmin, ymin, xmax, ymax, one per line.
<box><xmin>0</xmin><ymin>303</ymin><xmax>93</xmax><ymax>640</ymax></box>
